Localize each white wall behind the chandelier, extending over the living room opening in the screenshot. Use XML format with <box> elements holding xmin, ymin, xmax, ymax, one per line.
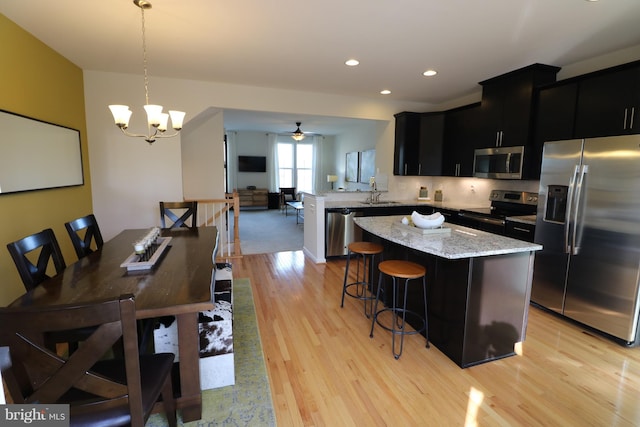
<box><xmin>84</xmin><ymin>70</ymin><xmax>431</xmax><ymax>239</ymax></box>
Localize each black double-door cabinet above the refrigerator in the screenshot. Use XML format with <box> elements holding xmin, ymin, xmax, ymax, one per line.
<box><xmin>575</xmin><ymin>61</ymin><xmax>640</xmax><ymax>138</ymax></box>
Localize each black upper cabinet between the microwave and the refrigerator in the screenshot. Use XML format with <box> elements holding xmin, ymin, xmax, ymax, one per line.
<box><xmin>525</xmin><ymin>81</ymin><xmax>578</xmax><ymax>179</ymax></box>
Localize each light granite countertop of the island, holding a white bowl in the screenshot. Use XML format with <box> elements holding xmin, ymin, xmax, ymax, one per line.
<box><xmin>354</xmin><ymin>215</ymin><xmax>542</xmax><ymax>259</ymax></box>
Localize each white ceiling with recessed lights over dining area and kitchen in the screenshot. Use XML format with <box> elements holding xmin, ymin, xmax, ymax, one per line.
<box><xmin>0</xmin><ymin>0</ymin><xmax>640</xmax><ymax>132</ymax></box>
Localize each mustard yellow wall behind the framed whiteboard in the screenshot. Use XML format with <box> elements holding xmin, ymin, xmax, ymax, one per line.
<box><xmin>0</xmin><ymin>14</ymin><xmax>92</xmax><ymax>306</ymax></box>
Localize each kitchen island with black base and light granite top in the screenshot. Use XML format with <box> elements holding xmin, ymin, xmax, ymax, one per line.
<box><xmin>354</xmin><ymin>216</ymin><xmax>542</xmax><ymax>368</ymax></box>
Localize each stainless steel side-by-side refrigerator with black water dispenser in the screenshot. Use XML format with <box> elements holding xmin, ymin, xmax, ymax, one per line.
<box><xmin>531</xmin><ymin>135</ymin><xmax>640</xmax><ymax>345</ymax></box>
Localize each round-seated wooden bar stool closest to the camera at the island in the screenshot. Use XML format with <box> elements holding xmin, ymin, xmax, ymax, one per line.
<box><xmin>369</xmin><ymin>260</ymin><xmax>429</xmax><ymax>360</ymax></box>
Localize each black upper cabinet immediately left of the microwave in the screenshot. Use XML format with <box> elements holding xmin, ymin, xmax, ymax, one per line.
<box><xmin>442</xmin><ymin>102</ymin><xmax>482</xmax><ymax>177</ymax></box>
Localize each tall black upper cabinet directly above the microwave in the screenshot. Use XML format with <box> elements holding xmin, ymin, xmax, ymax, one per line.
<box><xmin>477</xmin><ymin>64</ymin><xmax>560</xmax><ymax>149</ymax></box>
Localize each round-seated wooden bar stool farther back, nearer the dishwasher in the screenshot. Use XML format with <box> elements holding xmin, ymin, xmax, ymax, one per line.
<box><xmin>340</xmin><ymin>242</ymin><xmax>384</xmax><ymax>318</ymax></box>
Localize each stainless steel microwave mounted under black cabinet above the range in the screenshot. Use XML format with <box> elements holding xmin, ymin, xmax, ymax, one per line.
<box><xmin>473</xmin><ymin>145</ymin><xmax>524</xmax><ymax>179</ymax></box>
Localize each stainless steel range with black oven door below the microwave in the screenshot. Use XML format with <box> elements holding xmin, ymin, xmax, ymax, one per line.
<box><xmin>459</xmin><ymin>190</ymin><xmax>538</xmax><ymax>238</ymax></box>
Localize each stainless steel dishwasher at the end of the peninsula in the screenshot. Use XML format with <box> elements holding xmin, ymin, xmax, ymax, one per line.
<box><xmin>325</xmin><ymin>208</ymin><xmax>364</xmax><ymax>257</ymax></box>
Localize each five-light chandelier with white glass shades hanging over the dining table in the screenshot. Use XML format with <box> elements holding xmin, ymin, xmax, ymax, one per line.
<box><xmin>109</xmin><ymin>0</ymin><xmax>185</xmax><ymax>144</ymax></box>
